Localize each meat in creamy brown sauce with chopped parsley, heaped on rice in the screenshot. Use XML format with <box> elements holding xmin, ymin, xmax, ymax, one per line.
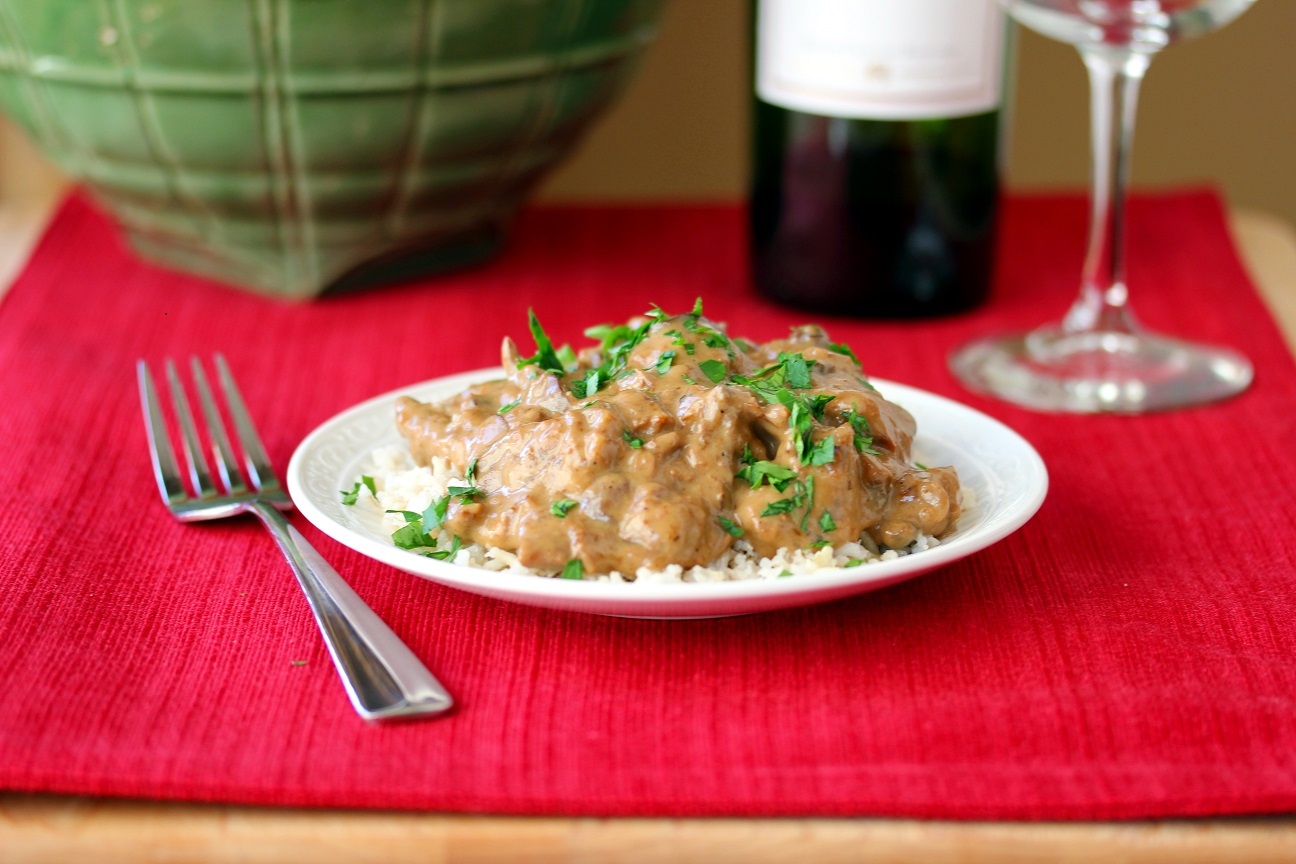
<box><xmin>395</xmin><ymin>306</ymin><xmax>959</xmax><ymax>574</ymax></box>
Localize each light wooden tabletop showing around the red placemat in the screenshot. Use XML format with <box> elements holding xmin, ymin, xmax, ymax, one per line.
<box><xmin>0</xmin><ymin>196</ymin><xmax>1296</xmax><ymax>864</ymax></box>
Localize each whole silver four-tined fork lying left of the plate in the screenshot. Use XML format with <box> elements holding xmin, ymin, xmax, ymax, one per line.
<box><xmin>137</xmin><ymin>354</ymin><xmax>454</xmax><ymax>720</ymax></box>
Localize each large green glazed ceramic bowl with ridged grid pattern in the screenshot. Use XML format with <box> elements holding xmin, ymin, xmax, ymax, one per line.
<box><xmin>0</xmin><ymin>0</ymin><xmax>665</xmax><ymax>298</ymax></box>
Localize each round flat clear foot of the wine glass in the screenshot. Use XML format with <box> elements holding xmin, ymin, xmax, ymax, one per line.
<box><xmin>950</xmin><ymin>328</ymin><xmax>1252</xmax><ymax>413</ymax></box>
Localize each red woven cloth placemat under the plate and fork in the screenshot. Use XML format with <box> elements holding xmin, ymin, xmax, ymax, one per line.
<box><xmin>0</xmin><ymin>193</ymin><xmax>1296</xmax><ymax>819</ymax></box>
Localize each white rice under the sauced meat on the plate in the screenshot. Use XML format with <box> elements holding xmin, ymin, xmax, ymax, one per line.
<box><xmin>355</xmin><ymin>446</ymin><xmax>967</xmax><ymax>583</ymax></box>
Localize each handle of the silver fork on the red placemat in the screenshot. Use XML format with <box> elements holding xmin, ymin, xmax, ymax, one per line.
<box><xmin>249</xmin><ymin>500</ymin><xmax>455</xmax><ymax>720</ymax></box>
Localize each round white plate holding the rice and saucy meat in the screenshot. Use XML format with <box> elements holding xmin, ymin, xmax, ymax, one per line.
<box><xmin>288</xmin><ymin>368</ymin><xmax>1048</xmax><ymax>618</ymax></box>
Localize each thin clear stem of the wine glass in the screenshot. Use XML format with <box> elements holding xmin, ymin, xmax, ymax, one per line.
<box><xmin>1063</xmin><ymin>45</ymin><xmax>1151</xmax><ymax>334</ymax></box>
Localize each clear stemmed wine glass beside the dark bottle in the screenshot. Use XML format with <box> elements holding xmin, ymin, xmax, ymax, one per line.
<box><xmin>950</xmin><ymin>0</ymin><xmax>1255</xmax><ymax>413</ymax></box>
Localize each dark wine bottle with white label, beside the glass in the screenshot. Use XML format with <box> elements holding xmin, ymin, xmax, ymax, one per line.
<box><xmin>749</xmin><ymin>0</ymin><xmax>1006</xmax><ymax>317</ymax></box>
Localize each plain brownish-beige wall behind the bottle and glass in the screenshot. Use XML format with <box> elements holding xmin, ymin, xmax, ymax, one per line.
<box><xmin>542</xmin><ymin>0</ymin><xmax>1296</xmax><ymax>224</ymax></box>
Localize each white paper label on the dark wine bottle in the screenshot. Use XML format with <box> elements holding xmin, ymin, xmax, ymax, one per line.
<box><xmin>756</xmin><ymin>0</ymin><xmax>1004</xmax><ymax>120</ymax></box>
